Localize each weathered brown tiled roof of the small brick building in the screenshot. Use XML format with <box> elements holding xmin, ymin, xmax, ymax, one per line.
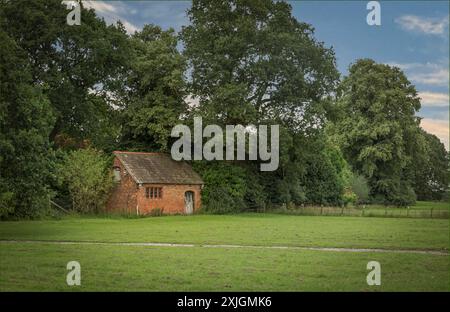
<box><xmin>114</xmin><ymin>151</ymin><xmax>203</xmax><ymax>184</ymax></box>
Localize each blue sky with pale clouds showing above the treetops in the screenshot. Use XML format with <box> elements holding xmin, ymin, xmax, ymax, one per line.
<box><xmin>83</xmin><ymin>1</ymin><xmax>449</xmax><ymax>149</ymax></box>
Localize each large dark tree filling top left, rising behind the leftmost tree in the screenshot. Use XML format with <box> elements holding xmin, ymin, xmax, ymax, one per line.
<box><xmin>0</xmin><ymin>0</ymin><xmax>129</xmax><ymax>145</ymax></box>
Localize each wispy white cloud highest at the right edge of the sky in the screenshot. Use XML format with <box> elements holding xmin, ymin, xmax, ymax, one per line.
<box><xmin>395</xmin><ymin>15</ymin><xmax>449</xmax><ymax>35</ymax></box>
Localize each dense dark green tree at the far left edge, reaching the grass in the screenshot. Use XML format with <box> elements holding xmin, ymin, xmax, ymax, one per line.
<box><xmin>0</xmin><ymin>28</ymin><xmax>55</xmax><ymax>218</ymax></box>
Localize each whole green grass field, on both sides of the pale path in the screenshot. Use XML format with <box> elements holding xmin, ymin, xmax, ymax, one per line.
<box><xmin>0</xmin><ymin>214</ymin><xmax>450</xmax><ymax>291</ymax></box>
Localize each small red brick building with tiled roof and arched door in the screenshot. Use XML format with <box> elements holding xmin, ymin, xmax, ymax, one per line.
<box><xmin>106</xmin><ymin>151</ymin><xmax>203</xmax><ymax>215</ymax></box>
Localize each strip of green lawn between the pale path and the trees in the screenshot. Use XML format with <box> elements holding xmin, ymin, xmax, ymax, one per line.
<box><xmin>0</xmin><ymin>213</ymin><xmax>449</xmax><ymax>249</ymax></box>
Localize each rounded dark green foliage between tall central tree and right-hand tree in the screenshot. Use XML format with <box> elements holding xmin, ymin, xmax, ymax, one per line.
<box><xmin>266</xmin><ymin>131</ymin><xmax>349</xmax><ymax>205</ymax></box>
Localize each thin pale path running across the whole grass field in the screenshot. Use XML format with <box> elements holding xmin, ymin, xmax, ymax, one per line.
<box><xmin>0</xmin><ymin>240</ymin><xmax>450</xmax><ymax>256</ymax></box>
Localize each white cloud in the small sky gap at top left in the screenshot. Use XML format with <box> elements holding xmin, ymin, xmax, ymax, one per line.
<box><xmin>83</xmin><ymin>0</ymin><xmax>139</xmax><ymax>34</ymax></box>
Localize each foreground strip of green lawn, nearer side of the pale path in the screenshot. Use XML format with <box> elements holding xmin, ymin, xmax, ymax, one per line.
<box><xmin>0</xmin><ymin>244</ymin><xmax>450</xmax><ymax>291</ymax></box>
